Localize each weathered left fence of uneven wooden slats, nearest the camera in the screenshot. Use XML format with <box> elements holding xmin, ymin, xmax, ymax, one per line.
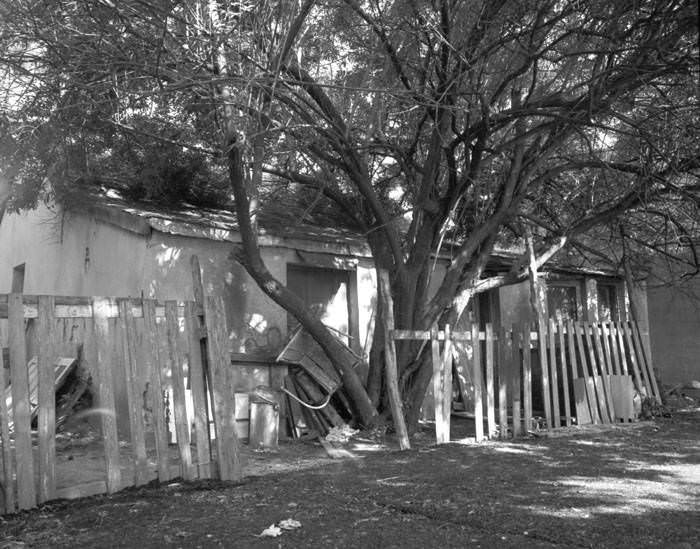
<box><xmin>0</xmin><ymin>294</ymin><xmax>241</xmax><ymax>512</ymax></box>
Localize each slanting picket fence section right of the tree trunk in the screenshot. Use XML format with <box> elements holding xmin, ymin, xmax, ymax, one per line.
<box><xmin>392</xmin><ymin>320</ymin><xmax>661</xmax><ymax>443</ymax></box>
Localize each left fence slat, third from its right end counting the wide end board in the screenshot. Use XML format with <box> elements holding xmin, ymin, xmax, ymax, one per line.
<box><xmin>165</xmin><ymin>301</ymin><xmax>194</xmax><ymax>480</ymax></box>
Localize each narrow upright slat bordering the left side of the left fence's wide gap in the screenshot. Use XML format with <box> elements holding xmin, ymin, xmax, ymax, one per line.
<box><xmin>37</xmin><ymin>296</ymin><xmax>56</xmax><ymax>503</ymax></box>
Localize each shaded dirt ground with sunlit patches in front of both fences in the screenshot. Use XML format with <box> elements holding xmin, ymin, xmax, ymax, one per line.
<box><xmin>0</xmin><ymin>409</ymin><xmax>700</xmax><ymax>548</ymax></box>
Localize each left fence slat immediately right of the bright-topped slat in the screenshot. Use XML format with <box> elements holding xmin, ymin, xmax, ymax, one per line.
<box><xmin>118</xmin><ymin>299</ymin><xmax>148</xmax><ymax>486</ymax></box>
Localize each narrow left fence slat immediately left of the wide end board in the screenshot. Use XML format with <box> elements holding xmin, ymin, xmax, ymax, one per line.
<box><xmin>185</xmin><ymin>301</ymin><xmax>211</xmax><ymax>478</ymax></box>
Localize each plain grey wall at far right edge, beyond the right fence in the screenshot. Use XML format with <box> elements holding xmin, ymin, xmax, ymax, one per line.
<box><xmin>647</xmin><ymin>277</ymin><xmax>700</xmax><ymax>385</ymax></box>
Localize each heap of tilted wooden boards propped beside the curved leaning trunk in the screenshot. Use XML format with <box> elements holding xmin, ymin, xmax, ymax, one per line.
<box><xmin>277</xmin><ymin>330</ymin><xmax>359</xmax><ymax>438</ymax></box>
